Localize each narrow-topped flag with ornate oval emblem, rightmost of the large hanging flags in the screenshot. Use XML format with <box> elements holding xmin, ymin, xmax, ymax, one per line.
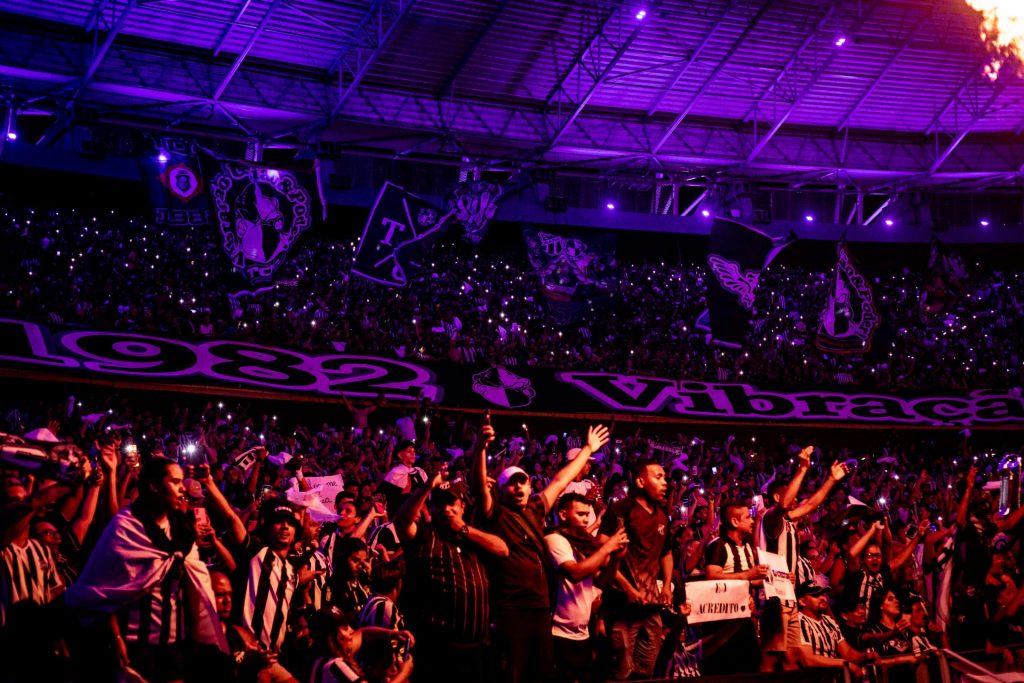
<box><xmin>815</xmin><ymin>240</ymin><xmax>879</xmax><ymax>353</ymax></box>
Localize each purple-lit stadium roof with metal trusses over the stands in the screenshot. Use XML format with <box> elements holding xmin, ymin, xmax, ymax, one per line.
<box><xmin>0</xmin><ymin>0</ymin><xmax>1024</xmax><ymax>191</ymax></box>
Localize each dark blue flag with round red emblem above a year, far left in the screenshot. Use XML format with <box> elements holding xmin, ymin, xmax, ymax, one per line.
<box><xmin>142</xmin><ymin>137</ymin><xmax>210</xmax><ymax>227</ymax></box>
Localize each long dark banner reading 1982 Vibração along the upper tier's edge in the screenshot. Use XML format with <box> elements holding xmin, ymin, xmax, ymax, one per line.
<box><xmin>0</xmin><ymin>318</ymin><xmax>1024</xmax><ymax>427</ymax></box>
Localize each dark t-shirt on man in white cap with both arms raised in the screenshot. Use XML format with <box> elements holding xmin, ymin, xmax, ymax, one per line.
<box><xmin>486</xmin><ymin>496</ymin><xmax>551</xmax><ymax>610</ymax></box>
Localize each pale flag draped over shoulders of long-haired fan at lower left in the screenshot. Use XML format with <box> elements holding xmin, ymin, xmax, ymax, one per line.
<box><xmin>65</xmin><ymin>506</ymin><xmax>229</xmax><ymax>652</ymax></box>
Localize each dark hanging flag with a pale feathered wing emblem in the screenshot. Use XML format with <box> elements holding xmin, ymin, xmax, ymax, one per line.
<box><xmin>697</xmin><ymin>218</ymin><xmax>790</xmax><ymax>347</ymax></box>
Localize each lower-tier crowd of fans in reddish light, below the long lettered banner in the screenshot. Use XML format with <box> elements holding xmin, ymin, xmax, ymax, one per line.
<box><xmin>0</xmin><ymin>395</ymin><xmax>1024</xmax><ymax>683</ymax></box>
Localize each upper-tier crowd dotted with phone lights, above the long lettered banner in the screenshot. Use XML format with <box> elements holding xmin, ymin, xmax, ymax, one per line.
<box><xmin>0</xmin><ymin>209</ymin><xmax>1024</xmax><ymax>389</ymax></box>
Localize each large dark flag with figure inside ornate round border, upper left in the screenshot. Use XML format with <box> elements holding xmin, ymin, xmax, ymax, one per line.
<box><xmin>203</xmin><ymin>156</ymin><xmax>326</xmax><ymax>284</ymax></box>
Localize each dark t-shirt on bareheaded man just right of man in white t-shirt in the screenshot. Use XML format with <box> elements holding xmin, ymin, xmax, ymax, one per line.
<box><xmin>600</xmin><ymin>497</ymin><xmax>672</xmax><ymax>602</ymax></box>
